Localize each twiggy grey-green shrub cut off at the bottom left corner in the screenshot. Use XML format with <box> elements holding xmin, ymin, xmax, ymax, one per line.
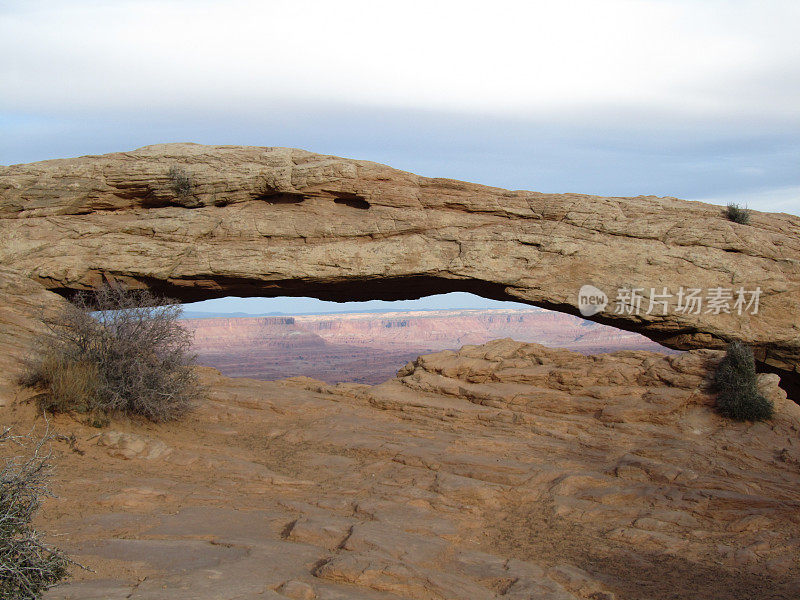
<box><xmin>0</xmin><ymin>429</ymin><xmax>69</xmax><ymax>600</ymax></box>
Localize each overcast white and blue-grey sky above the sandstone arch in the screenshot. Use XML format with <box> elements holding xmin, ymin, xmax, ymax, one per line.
<box><xmin>0</xmin><ymin>0</ymin><xmax>800</xmax><ymax>314</ymax></box>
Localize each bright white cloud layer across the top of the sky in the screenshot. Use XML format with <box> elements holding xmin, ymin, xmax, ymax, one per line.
<box><xmin>0</xmin><ymin>0</ymin><xmax>800</xmax><ymax>121</ymax></box>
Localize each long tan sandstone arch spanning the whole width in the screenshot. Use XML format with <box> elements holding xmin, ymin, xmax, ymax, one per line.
<box><xmin>0</xmin><ymin>144</ymin><xmax>800</xmax><ymax>400</ymax></box>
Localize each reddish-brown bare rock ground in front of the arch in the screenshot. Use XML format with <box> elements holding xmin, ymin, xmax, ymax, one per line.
<box><xmin>0</xmin><ymin>340</ymin><xmax>800</xmax><ymax>600</ymax></box>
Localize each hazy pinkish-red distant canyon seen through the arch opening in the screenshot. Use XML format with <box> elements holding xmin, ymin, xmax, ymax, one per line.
<box><xmin>182</xmin><ymin>308</ymin><xmax>675</xmax><ymax>384</ymax></box>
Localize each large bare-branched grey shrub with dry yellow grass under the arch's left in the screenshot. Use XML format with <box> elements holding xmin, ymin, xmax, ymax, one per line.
<box><xmin>19</xmin><ymin>286</ymin><xmax>202</xmax><ymax>424</ymax></box>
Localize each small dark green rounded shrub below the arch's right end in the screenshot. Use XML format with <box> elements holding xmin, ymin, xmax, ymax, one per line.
<box><xmin>714</xmin><ymin>342</ymin><xmax>774</xmax><ymax>421</ymax></box>
